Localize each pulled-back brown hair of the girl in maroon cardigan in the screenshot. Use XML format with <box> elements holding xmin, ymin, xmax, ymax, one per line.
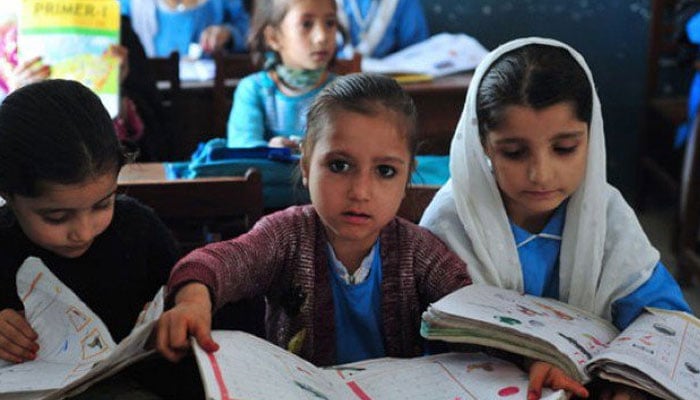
<box><xmin>302</xmin><ymin>74</ymin><xmax>418</xmax><ymax>168</ymax></box>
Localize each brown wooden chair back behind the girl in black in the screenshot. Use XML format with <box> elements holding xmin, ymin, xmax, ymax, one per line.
<box><xmin>119</xmin><ymin>168</ymin><xmax>263</xmax><ymax>251</ymax></box>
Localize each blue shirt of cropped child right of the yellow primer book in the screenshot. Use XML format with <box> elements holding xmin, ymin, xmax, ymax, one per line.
<box><xmin>121</xmin><ymin>0</ymin><xmax>250</xmax><ymax>57</ymax></box>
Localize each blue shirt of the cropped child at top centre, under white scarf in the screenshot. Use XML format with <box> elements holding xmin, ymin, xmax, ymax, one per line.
<box><xmin>344</xmin><ymin>0</ymin><xmax>430</xmax><ymax>58</ymax></box>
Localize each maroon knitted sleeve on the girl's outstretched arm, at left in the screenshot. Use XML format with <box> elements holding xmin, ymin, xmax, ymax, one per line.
<box><xmin>168</xmin><ymin>209</ymin><xmax>295</xmax><ymax>310</ymax></box>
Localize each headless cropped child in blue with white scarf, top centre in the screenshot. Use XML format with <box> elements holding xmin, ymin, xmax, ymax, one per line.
<box><xmin>336</xmin><ymin>0</ymin><xmax>430</xmax><ymax>58</ymax></box>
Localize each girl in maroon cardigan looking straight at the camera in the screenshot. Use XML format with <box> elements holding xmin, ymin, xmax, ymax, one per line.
<box><xmin>156</xmin><ymin>74</ymin><xmax>470</xmax><ymax>365</ymax></box>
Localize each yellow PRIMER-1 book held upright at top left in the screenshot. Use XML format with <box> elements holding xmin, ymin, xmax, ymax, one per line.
<box><xmin>17</xmin><ymin>0</ymin><xmax>120</xmax><ymax>117</ymax></box>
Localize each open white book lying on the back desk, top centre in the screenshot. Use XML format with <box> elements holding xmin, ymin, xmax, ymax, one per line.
<box><xmin>362</xmin><ymin>33</ymin><xmax>488</xmax><ymax>78</ymax></box>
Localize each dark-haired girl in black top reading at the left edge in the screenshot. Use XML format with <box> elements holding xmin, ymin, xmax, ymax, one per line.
<box><xmin>0</xmin><ymin>80</ymin><xmax>177</xmax><ymax>396</ymax></box>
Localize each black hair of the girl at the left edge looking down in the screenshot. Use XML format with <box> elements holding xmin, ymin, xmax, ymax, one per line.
<box><xmin>0</xmin><ymin>79</ymin><xmax>126</xmax><ymax>197</ymax></box>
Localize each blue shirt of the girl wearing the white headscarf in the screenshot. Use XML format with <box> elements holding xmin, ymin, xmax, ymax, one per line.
<box><xmin>510</xmin><ymin>202</ymin><xmax>691</xmax><ymax>329</ymax></box>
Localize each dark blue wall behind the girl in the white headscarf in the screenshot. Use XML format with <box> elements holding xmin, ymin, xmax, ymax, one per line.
<box><xmin>421</xmin><ymin>0</ymin><xmax>685</xmax><ymax>200</ymax></box>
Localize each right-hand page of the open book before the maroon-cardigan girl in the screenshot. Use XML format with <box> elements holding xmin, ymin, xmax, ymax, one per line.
<box><xmin>329</xmin><ymin>353</ymin><xmax>566</xmax><ymax>400</ymax></box>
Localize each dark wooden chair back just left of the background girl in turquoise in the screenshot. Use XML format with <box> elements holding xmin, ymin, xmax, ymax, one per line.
<box><xmin>212</xmin><ymin>53</ymin><xmax>258</xmax><ymax>136</ymax></box>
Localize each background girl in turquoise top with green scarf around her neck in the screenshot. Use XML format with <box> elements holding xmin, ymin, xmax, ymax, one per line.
<box><xmin>227</xmin><ymin>0</ymin><xmax>338</xmax><ymax>149</ymax></box>
